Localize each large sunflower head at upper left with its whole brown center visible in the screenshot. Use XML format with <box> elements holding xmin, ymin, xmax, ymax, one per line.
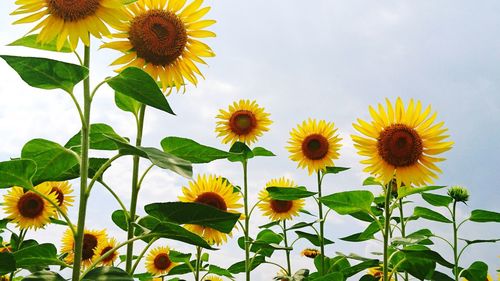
<box><xmin>102</xmin><ymin>0</ymin><xmax>215</xmax><ymax>91</ymax></box>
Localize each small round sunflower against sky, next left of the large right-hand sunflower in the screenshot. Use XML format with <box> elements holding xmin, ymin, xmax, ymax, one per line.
<box><xmin>287</xmin><ymin>118</ymin><xmax>341</xmax><ymax>175</ymax></box>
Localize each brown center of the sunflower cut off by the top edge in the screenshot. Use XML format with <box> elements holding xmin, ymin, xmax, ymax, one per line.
<box><xmin>47</xmin><ymin>0</ymin><xmax>101</xmax><ymax>22</ymax></box>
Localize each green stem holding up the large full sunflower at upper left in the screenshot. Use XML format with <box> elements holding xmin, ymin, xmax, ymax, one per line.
<box><xmin>125</xmin><ymin>104</ymin><xmax>146</xmax><ymax>272</ymax></box>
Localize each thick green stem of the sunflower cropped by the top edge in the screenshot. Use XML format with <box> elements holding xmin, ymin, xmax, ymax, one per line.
<box><xmin>72</xmin><ymin>43</ymin><xmax>92</xmax><ymax>281</ymax></box>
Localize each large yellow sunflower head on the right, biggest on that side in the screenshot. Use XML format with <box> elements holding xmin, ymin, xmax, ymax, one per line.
<box><xmin>352</xmin><ymin>98</ymin><xmax>453</xmax><ymax>187</ymax></box>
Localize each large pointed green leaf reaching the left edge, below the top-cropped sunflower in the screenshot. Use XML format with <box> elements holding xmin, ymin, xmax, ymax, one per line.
<box><xmin>0</xmin><ymin>55</ymin><xmax>89</xmax><ymax>93</ymax></box>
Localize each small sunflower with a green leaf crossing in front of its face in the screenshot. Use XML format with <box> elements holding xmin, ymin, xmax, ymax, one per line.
<box><xmin>258</xmin><ymin>177</ymin><xmax>305</xmax><ymax>221</ymax></box>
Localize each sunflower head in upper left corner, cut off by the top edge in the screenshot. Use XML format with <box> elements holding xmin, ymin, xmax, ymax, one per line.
<box><xmin>12</xmin><ymin>0</ymin><xmax>125</xmax><ymax>50</ymax></box>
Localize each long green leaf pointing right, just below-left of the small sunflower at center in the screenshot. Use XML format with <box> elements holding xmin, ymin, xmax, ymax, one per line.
<box><xmin>161</xmin><ymin>137</ymin><xmax>231</xmax><ymax>164</ymax></box>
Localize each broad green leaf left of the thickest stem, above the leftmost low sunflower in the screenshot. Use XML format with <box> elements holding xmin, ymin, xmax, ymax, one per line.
<box><xmin>21</xmin><ymin>139</ymin><xmax>79</xmax><ymax>185</ymax></box>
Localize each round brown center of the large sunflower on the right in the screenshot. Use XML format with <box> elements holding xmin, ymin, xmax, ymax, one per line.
<box><xmin>377</xmin><ymin>124</ymin><xmax>423</xmax><ymax>167</ymax></box>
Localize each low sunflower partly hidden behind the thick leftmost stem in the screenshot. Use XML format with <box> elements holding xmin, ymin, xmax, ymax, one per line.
<box><xmin>61</xmin><ymin>225</ymin><xmax>107</xmax><ymax>268</ymax></box>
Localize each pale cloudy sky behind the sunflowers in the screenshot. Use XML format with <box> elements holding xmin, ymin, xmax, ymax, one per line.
<box><xmin>0</xmin><ymin>0</ymin><xmax>500</xmax><ymax>280</ymax></box>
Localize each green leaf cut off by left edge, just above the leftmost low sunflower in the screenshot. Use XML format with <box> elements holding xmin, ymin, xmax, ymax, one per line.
<box><xmin>0</xmin><ymin>159</ymin><xmax>36</xmax><ymax>189</ymax></box>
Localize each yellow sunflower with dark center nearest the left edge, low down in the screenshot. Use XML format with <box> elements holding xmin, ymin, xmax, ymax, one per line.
<box><xmin>4</xmin><ymin>183</ymin><xmax>57</xmax><ymax>229</ymax></box>
